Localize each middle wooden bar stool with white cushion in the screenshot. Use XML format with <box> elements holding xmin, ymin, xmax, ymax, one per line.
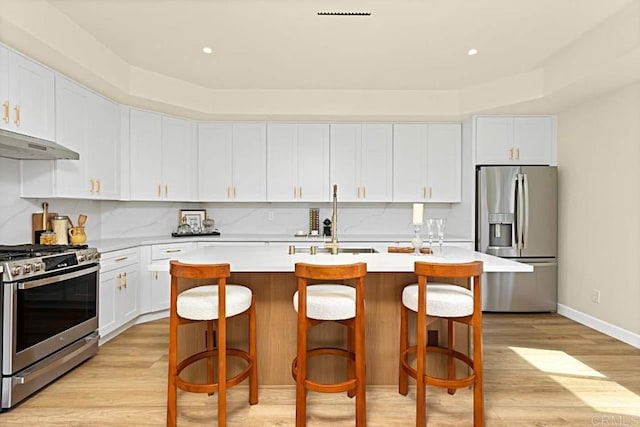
<box><xmin>291</xmin><ymin>262</ymin><xmax>367</xmax><ymax>427</ymax></box>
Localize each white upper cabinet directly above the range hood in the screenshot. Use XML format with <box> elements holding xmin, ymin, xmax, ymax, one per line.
<box><xmin>0</xmin><ymin>46</ymin><xmax>56</xmax><ymax>141</ymax></box>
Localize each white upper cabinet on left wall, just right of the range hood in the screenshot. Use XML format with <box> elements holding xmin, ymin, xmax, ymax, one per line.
<box><xmin>22</xmin><ymin>76</ymin><xmax>120</xmax><ymax>200</ymax></box>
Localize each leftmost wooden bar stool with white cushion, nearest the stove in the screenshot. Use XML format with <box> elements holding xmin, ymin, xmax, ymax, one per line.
<box><xmin>167</xmin><ymin>261</ymin><xmax>258</xmax><ymax>426</ymax></box>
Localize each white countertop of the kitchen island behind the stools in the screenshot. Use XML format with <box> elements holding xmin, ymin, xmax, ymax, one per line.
<box><xmin>149</xmin><ymin>245</ymin><xmax>533</xmax><ymax>273</ymax></box>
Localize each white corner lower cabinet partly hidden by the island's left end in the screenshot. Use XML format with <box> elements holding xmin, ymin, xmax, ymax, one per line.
<box><xmin>150</xmin><ymin>242</ymin><xmax>196</xmax><ymax>312</ymax></box>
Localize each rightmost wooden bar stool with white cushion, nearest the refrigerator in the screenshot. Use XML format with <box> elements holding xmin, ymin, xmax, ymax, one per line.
<box><xmin>398</xmin><ymin>261</ymin><xmax>484</xmax><ymax>426</ymax></box>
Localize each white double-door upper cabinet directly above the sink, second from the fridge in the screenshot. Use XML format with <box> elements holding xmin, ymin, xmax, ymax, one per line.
<box><xmin>330</xmin><ymin>124</ymin><xmax>393</xmax><ymax>202</ymax></box>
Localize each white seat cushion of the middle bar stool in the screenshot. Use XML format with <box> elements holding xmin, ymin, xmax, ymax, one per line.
<box><xmin>293</xmin><ymin>284</ymin><xmax>356</xmax><ymax>320</ymax></box>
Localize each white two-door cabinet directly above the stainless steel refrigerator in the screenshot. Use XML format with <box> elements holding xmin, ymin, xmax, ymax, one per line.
<box><xmin>475</xmin><ymin>116</ymin><xmax>556</xmax><ymax>165</ymax></box>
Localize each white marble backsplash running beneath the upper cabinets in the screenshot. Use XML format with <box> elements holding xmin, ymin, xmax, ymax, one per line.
<box><xmin>0</xmin><ymin>158</ymin><xmax>473</xmax><ymax>244</ymax></box>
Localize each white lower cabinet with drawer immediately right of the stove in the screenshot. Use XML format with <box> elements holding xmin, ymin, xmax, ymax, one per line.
<box><xmin>98</xmin><ymin>247</ymin><xmax>140</xmax><ymax>340</ymax></box>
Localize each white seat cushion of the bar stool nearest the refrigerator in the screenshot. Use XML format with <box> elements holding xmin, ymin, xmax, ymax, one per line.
<box><xmin>402</xmin><ymin>283</ymin><xmax>473</xmax><ymax>317</ymax></box>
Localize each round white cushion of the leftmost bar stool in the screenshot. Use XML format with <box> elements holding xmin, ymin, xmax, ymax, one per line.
<box><xmin>177</xmin><ymin>283</ymin><xmax>252</xmax><ymax>320</ymax></box>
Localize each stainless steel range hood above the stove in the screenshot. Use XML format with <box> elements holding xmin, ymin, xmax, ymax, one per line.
<box><xmin>0</xmin><ymin>129</ymin><xmax>80</xmax><ymax>160</ymax></box>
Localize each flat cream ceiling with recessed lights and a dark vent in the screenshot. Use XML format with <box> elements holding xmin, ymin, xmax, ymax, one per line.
<box><xmin>0</xmin><ymin>0</ymin><xmax>638</xmax><ymax>118</ymax></box>
